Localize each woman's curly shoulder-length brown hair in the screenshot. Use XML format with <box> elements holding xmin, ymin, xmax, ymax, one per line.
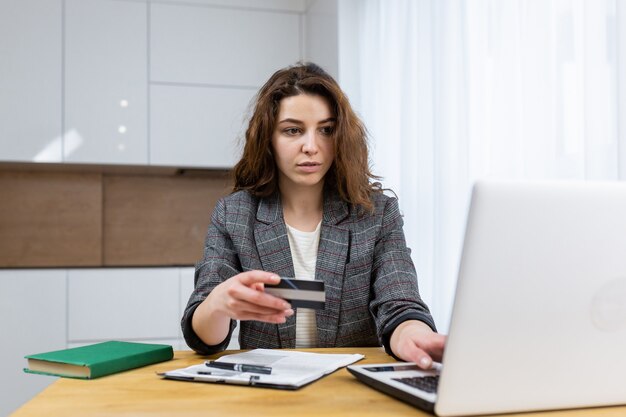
<box><xmin>233</xmin><ymin>62</ymin><xmax>381</xmax><ymax>211</ymax></box>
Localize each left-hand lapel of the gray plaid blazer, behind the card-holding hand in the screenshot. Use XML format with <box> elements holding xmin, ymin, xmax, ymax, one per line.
<box><xmin>254</xmin><ymin>193</ymin><xmax>296</xmax><ymax>348</ymax></box>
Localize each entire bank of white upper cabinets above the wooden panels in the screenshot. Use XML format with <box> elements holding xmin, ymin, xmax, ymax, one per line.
<box><xmin>0</xmin><ymin>0</ymin><xmax>337</xmax><ymax>168</ymax></box>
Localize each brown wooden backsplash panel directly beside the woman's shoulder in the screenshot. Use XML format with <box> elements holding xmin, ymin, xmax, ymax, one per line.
<box><xmin>103</xmin><ymin>172</ymin><xmax>231</xmax><ymax>266</ymax></box>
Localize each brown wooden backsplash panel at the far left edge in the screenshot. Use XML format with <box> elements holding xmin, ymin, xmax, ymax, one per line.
<box><xmin>0</xmin><ymin>171</ymin><xmax>102</xmax><ymax>267</ymax></box>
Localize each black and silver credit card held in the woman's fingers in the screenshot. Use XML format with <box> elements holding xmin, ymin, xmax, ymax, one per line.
<box><xmin>265</xmin><ymin>277</ymin><xmax>326</xmax><ymax>310</ymax></box>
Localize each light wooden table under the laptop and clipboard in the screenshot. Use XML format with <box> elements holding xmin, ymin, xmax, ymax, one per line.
<box><xmin>12</xmin><ymin>348</ymin><xmax>626</xmax><ymax>417</ymax></box>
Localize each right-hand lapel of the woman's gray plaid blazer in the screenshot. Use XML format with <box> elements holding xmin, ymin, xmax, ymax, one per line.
<box><xmin>315</xmin><ymin>194</ymin><xmax>350</xmax><ymax>347</ymax></box>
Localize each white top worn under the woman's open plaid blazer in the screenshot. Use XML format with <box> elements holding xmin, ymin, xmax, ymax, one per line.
<box><xmin>287</xmin><ymin>221</ymin><xmax>322</xmax><ymax>349</ymax></box>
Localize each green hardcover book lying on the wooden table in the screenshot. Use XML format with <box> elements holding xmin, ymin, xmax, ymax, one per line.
<box><xmin>24</xmin><ymin>341</ymin><xmax>174</xmax><ymax>379</ymax></box>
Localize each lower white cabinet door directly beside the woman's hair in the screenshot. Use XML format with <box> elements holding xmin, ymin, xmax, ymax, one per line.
<box><xmin>150</xmin><ymin>85</ymin><xmax>256</xmax><ymax>168</ymax></box>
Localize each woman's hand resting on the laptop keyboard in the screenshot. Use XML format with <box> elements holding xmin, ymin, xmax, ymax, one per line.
<box><xmin>389</xmin><ymin>320</ymin><xmax>446</xmax><ymax>369</ymax></box>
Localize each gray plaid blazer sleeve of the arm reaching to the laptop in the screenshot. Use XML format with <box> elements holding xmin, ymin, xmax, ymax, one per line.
<box><xmin>370</xmin><ymin>198</ymin><xmax>436</xmax><ymax>357</ymax></box>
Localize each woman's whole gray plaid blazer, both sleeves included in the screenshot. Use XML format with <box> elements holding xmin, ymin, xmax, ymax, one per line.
<box><xmin>181</xmin><ymin>191</ymin><xmax>435</xmax><ymax>354</ymax></box>
